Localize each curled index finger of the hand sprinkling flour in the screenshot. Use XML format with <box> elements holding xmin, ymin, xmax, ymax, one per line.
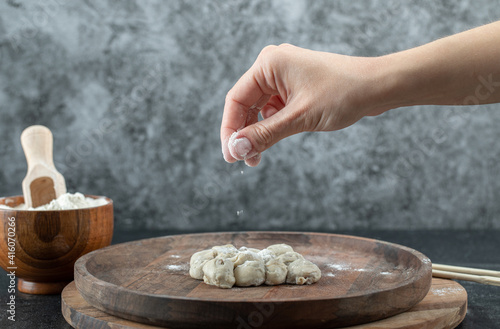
<box><xmin>220</xmin><ymin>65</ymin><xmax>270</xmax><ymax>162</ymax></box>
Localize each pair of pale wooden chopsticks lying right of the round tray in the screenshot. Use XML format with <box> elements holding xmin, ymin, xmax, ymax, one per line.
<box><xmin>432</xmin><ymin>264</ymin><xmax>500</xmax><ymax>286</ymax></box>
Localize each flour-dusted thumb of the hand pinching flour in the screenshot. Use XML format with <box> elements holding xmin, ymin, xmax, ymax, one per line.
<box><xmin>228</xmin><ymin>104</ymin><xmax>304</xmax><ymax>164</ymax></box>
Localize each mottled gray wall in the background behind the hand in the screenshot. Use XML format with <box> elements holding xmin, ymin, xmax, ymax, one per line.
<box><xmin>0</xmin><ymin>0</ymin><xmax>500</xmax><ymax>230</ymax></box>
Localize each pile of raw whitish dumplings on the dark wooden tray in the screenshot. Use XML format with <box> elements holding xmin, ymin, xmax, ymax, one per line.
<box><xmin>189</xmin><ymin>244</ymin><xmax>321</xmax><ymax>289</ymax></box>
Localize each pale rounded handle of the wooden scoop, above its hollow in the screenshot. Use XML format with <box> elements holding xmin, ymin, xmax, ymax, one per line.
<box><xmin>21</xmin><ymin>125</ymin><xmax>55</xmax><ymax>171</ymax></box>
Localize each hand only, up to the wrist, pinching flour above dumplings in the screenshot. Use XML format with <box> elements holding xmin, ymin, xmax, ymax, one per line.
<box><xmin>220</xmin><ymin>45</ymin><xmax>388</xmax><ymax>166</ymax></box>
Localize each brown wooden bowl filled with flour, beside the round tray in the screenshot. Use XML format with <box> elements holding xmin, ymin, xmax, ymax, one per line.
<box><xmin>0</xmin><ymin>195</ymin><xmax>113</xmax><ymax>294</ymax></box>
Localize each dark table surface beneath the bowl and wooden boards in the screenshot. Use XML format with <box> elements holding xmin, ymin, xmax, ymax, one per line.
<box><xmin>0</xmin><ymin>230</ymin><xmax>500</xmax><ymax>329</ymax></box>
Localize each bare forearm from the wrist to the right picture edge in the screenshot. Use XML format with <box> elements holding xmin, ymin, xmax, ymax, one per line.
<box><xmin>376</xmin><ymin>22</ymin><xmax>500</xmax><ymax>110</ymax></box>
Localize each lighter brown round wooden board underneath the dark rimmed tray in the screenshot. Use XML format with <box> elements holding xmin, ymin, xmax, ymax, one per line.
<box><xmin>61</xmin><ymin>278</ymin><xmax>467</xmax><ymax>329</ymax></box>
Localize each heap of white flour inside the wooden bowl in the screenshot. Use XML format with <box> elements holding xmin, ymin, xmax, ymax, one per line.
<box><xmin>0</xmin><ymin>192</ymin><xmax>108</xmax><ymax>210</ymax></box>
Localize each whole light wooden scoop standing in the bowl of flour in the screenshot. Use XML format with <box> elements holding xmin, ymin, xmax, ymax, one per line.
<box><xmin>21</xmin><ymin>126</ymin><xmax>66</xmax><ymax>208</ymax></box>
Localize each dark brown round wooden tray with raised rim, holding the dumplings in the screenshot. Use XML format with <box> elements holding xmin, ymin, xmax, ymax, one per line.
<box><xmin>75</xmin><ymin>232</ymin><xmax>432</xmax><ymax>329</ymax></box>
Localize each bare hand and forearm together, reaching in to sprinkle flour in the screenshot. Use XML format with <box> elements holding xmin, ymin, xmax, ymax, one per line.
<box><xmin>224</xmin><ymin>21</ymin><xmax>500</xmax><ymax>166</ymax></box>
